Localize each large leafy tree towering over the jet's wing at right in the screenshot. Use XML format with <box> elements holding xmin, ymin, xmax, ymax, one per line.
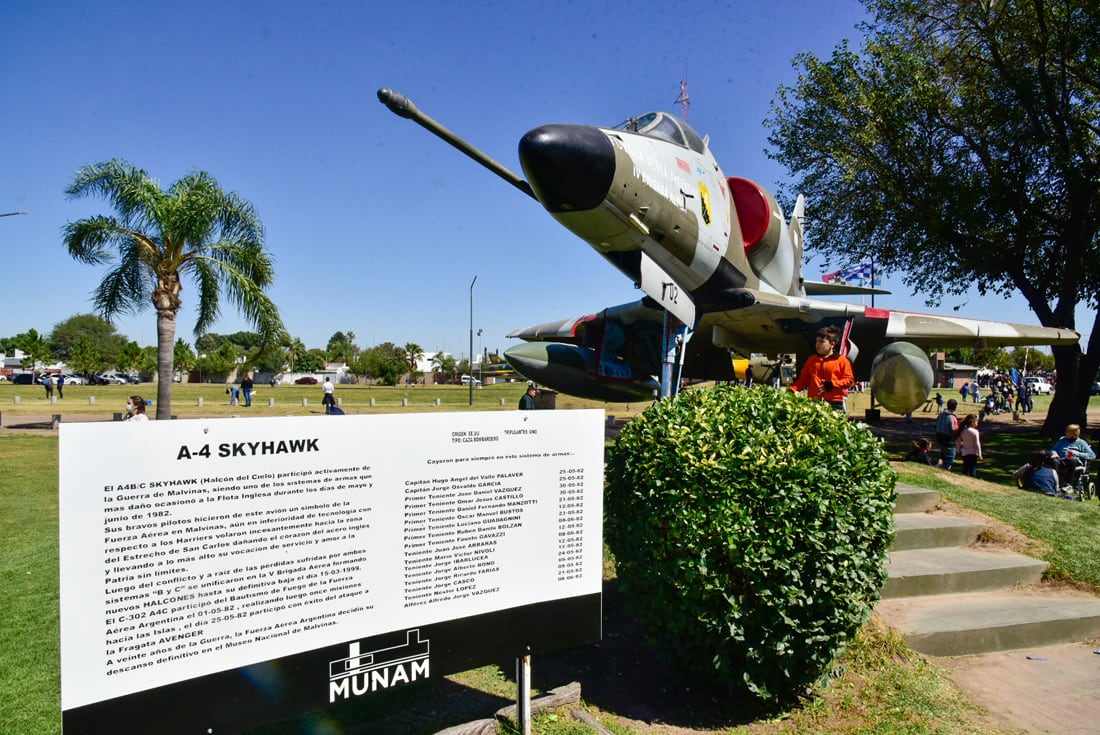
<box><xmin>768</xmin><ymin>0</ymin><xmax>1100</xmax><ymax>434</ymax></box>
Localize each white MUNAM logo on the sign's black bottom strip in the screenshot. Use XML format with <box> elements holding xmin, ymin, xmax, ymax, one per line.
<box><xmin>329</xmin><ymin>628</ymin><xmax>430</xmax><ymax>703</ymax></box>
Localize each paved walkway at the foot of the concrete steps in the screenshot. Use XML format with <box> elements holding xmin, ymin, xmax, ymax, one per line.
<box><xmin>931</xmin><ymin>641</ymin><xmax>1100</xmax><ymax>735</ymax></box>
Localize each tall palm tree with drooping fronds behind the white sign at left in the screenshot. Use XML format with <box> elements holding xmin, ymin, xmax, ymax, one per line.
<box><xmin>65</xmin><ymin>160</ymin><xmax>285</xmax><ymax>419</ymax></box>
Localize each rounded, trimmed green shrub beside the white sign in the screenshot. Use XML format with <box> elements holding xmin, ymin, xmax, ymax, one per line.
<box><xmin>605</xmin><ymin>387</ymin><xmax>894</xmax><ymax>704</ymax></box>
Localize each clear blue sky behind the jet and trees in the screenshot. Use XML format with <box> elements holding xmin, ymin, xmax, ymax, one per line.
<box><xmin>0</xmin><ymin>0</ymin><xmax>1082</xmax><ymax>354</ymax></box>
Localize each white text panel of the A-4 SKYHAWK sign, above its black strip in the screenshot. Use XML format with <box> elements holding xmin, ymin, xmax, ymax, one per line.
<box><xmin>59</xmin><ymin>410</ymin><xmax>604</xmax><ymax>710</ymax></box>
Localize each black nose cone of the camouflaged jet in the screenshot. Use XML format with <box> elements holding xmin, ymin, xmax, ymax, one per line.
<box><xmin>519</xmin><ymin>125</ymin><xmax>615</xmax><ymax>212</ymax></box>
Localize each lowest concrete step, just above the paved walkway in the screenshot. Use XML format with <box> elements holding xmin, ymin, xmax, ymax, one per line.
<box><xmin>875</xmin><ymin>589</ymin><xmax>1100</xmax><ymax>656</ymax></box>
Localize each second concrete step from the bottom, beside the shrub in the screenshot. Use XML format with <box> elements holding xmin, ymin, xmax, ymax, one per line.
<box><xmin>882</xmin><ymin>548</ymin><xmax>1048</xmax><ymax>599</ymax></box>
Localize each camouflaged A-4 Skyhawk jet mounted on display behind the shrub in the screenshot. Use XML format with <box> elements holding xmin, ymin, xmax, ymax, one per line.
<box><xmin>378</xmin><ymin>89</ymin><xmax>1079</xmax><ymax>413</ymax></box>
